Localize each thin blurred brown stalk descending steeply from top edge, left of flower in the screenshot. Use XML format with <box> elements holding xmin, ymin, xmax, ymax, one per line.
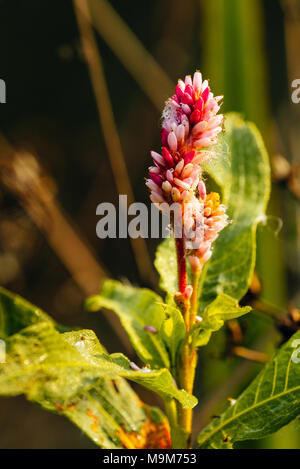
<box><xmin>74</xmin><ymin>0</ymin><xmax>155</xmax><ymax>284</ymax></box>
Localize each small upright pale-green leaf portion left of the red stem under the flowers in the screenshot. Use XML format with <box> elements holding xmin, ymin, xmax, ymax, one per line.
<box><xmin>154</xmin><ymin>237</ymin><xmax>178</xmax><ymax>297</ymax></box>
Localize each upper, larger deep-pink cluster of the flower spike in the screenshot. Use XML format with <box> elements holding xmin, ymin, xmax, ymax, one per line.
<box><xmin>146</xmin><ymin>72</ymin><xmax>223</xmax><ymax>204</ymax></box>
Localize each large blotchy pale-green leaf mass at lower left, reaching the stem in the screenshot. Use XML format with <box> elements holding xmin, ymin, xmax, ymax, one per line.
<box><xmin>0</xmin><ymin>289</ymin><xmax>196</xmax><ymax>448</ymax></box>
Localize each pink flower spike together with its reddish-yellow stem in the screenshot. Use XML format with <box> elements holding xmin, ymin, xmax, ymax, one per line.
<box><xmin>146</xmin><ymin>71</ymin><xmax>228</xmax><ymax>447</ymax></box>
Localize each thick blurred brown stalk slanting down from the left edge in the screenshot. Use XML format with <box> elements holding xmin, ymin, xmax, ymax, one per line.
<box><xmin>0</xmin><ymin>135</ymin><xmax>132</xmax><ymax>352</ymax></box>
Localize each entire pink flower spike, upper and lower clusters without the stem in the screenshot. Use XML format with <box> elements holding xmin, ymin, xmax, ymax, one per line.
<box><xmin>146</xmin><ymin>72</ymin><xmax>228</xmax><ymax>269</ymax></box>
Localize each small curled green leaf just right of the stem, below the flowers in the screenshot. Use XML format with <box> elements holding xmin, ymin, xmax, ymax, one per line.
<box><xmin>191</xmin><ymin>293</ymin><xmax>251</xmax><ymax>347</ymax></box>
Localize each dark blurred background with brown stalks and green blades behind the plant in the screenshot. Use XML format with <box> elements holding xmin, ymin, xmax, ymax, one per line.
<box><xmin>0</xmin><ymin>0</ymin><xmax>300</xmax><ymax>448</ymax></box>
